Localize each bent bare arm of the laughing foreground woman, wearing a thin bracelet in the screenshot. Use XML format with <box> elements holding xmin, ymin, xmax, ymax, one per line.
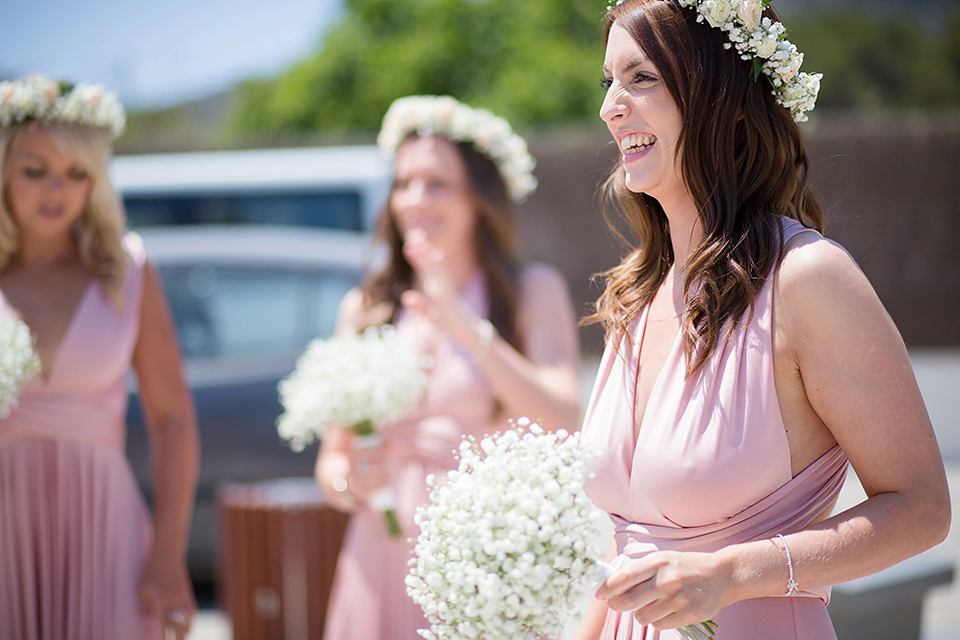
<box><xmin>716</xmin><ymin>236</ymin><xmax>950</xmax><ymax>593</ymax></box>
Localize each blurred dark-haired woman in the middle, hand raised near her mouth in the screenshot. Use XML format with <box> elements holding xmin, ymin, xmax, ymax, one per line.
<box><xmin>316</xmin><ymin>96</ymin><xmax>579</xmax><ymax>640</ymax></box>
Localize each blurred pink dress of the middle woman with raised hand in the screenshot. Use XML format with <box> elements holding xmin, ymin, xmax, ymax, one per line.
<box><xmin>323</xmin><ymin>274</ymin><xmax>503</xmax><ymax>640</ymax></box>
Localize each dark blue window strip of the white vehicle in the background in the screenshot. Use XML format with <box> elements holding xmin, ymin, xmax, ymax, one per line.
<box><xmin>123</xmin><ymin>190</ymin><xmax>363</xmax><ymax>231</ymax></box>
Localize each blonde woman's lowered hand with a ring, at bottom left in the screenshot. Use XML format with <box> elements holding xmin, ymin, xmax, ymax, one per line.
<box><xmin>138</xmin><ymin>554</ymin><xmax>197</xmax><ymax>640</ymax></box>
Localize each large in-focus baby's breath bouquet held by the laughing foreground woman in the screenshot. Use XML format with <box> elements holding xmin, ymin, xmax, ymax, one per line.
<box><xmin>406</xmin><ymin>418</ymin><xmax>603</xmax><ymax>640</ymax></box>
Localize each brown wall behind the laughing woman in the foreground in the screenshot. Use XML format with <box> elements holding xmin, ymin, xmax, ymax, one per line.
<box><xmin>521</xmin><ymin>115</ymin><xmax>960</xmax><ymax>355</ymax></box>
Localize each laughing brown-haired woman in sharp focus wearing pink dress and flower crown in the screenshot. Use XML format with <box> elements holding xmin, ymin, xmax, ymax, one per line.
<box><xmin>576</xmin><ymin>0</ymin><xmax>950</xmax><ymax>640</ymax></box>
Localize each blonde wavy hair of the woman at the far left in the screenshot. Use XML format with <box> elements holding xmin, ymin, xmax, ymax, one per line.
<box><xmin>0</xmin><ymin>122</ymin><xmax>127</xmax><ymax>308</ymax></box>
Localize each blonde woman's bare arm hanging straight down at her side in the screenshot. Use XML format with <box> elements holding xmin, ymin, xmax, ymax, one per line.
<box><xmin>133</xmin><ymin>263</ymin><xmax>200</xmax><ymax>637</ymax></box>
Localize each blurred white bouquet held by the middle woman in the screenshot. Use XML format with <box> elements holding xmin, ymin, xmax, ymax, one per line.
<box><xmin>277</xmin><ymin>325</ymin><xmax>428</xmax><ymax>537</ymax></box>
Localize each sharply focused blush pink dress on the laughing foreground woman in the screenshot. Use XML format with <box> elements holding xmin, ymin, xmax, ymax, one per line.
<box><xmin>582</xmin><ymin>219</ymin><xmax>847</xmax><ymax>640</ymax></box>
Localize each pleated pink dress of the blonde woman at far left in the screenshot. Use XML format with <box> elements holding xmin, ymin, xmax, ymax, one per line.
<box><xmin>0</xmin><ymin>233</ymin><xmax>160</xmax><ymax>640</ymax></box>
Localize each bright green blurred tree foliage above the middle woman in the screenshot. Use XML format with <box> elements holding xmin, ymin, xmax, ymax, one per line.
<box><xmin>225</xmin><ymin>0</ymin><xmax>605</xmax><ymax>132</ymax></box>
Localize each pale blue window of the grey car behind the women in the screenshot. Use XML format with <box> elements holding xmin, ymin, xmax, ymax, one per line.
<box><xmin>159</xmin><ymin>264</ymin><xmax>357</xmax><ymax>358</ymax></box>
